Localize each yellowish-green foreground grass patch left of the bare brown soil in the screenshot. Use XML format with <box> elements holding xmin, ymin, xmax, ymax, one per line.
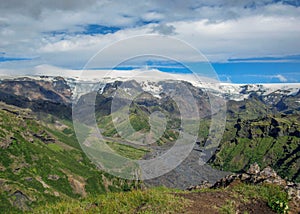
<box><xmin>34</xmin><ymin>188</ymin><xmax>187</xmax><ymax>213</ymax></box>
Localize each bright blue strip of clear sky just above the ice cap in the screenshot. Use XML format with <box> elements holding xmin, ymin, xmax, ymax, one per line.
<box><xmin>100</xmin><ymin>62</ymin><xmax>300</xmax><ymax>84</ymax></box>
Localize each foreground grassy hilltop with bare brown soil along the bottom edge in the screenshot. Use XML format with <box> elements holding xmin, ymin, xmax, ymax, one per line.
<box><xmin>33</xmin><ymin>184</ymin><xmax>288</xmax><ymax>213</ymax></box>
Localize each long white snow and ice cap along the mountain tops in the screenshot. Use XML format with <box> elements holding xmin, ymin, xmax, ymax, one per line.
<box><xmin>1</xmin><ymin>69</ymin><xmax>300</xmax><ymax>103</ymax></box>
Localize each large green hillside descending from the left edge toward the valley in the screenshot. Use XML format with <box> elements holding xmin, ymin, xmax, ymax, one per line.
<box><xmin>0</xmin><ymin>104</ymin><xmax>137</xmax><ymax>210</ymax></box>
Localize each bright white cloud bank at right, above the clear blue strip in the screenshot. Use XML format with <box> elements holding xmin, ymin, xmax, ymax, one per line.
<box><xmin>172</xmin><ymin>15</ymin><xmax>300</xmax><ymax>61</ymax></box>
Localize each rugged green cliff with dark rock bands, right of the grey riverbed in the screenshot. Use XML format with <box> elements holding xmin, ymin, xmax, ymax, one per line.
<box><xmin>211</xmin><ymin>114</ymin><xmax>300</xmax><ymax>182</ymax></box>
